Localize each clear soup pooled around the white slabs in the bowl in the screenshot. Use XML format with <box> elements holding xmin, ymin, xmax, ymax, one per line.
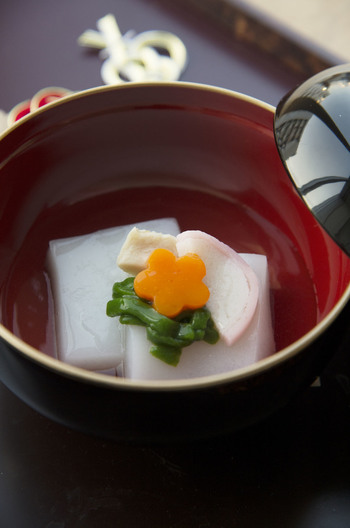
<box><xmin>2</xmin><ymin>187</ymin><xmax>317</xmax><ymax>357</ymax></box>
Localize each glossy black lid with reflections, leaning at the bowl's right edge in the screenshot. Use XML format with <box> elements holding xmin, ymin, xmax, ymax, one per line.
<box><xmin>275</xmin><ymin>64</ymin><xmax>350</xmax><ymax>256</ymax></box>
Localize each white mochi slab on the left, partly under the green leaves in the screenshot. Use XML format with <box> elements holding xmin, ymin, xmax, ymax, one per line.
<box><xmin>48</xmin><ymin>218</ymin><xmax>179</xmax><ymax>373</ymax></box>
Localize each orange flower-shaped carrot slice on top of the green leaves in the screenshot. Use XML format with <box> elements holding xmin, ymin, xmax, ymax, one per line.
<box><xmin>134</xmin><ymin>249</ymin><xmax>209</xmax><ymax>317</ymax></box>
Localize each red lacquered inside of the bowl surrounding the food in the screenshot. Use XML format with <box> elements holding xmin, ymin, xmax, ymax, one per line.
<box><xmin>0</xmin><ymin>83</ymin><xmax>350</xmax><ymax>370</ymax></box>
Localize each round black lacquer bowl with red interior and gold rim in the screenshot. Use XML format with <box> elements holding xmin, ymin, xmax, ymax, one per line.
<box><xmin>0</xmin><ymin>83</ymin><xmax>350</xmax><ymax>443</ymax></box>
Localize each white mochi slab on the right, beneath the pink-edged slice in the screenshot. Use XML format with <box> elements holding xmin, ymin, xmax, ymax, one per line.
<box><xmin>124</xmin><ymin>253</ymin><xmax>275</xmax><ymax>380</ymax></box>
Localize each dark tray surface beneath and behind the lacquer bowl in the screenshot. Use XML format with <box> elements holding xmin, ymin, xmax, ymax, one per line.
<box><xmin>0</xmin><ymin>0</ymin><xmax>350</xmax><ymax>528</ymax></box>
